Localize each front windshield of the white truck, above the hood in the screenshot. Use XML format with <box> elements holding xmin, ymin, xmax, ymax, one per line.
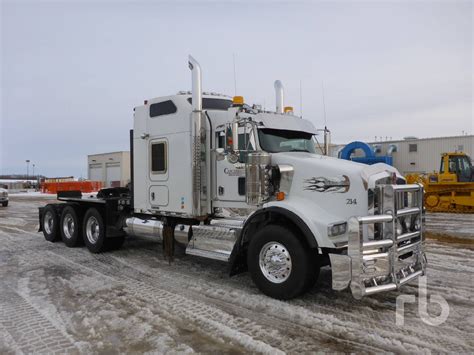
<box><xmin>258</xmin><ymin>128</ymin><xmax>316</xmax><ymax>153</ymax></box>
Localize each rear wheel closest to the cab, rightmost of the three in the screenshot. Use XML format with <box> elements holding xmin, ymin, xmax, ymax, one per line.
<box><xmin>82</xmin><ymin>208</ymin><xmax>107</xmax><ymax>254</ymax></box>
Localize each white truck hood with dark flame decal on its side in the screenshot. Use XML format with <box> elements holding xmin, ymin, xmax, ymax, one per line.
<box><xmin>267</xmin><ymin>152</ymin><xmax>401</xmax><ymax>247</ymax></box>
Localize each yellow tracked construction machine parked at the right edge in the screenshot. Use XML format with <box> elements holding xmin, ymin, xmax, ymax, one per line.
<box><xmin>406</xmin><ymin>152</ymin><xmax>474</xmax><ymax>213</ymax></box>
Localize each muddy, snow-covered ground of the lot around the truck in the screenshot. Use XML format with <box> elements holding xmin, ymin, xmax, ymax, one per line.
<box><xmin>0</xmin><ymin>196</ymin><xmax>474</xmax><ymax>354</ymax></box>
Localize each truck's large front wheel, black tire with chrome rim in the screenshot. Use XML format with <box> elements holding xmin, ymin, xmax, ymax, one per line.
<box><xmin>247</xmin><ymin>225</ymin><xmax>319</xmax><ymax>300</ymax></box>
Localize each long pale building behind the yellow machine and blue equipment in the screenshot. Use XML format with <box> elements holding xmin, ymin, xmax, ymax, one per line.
<box><xmin>330</xmin><ymin>135</ymin><xmax>474</xmax><ymax>175</ymax></box>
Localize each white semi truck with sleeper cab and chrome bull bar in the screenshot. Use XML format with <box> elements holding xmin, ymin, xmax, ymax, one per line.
<box><xmin>39</xmin><ymin>56</ymin><xmax>426</xmax><ymax>299</ymax></box>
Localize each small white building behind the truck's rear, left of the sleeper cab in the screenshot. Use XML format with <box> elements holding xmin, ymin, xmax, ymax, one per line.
<box><xmin>87</xmin><ymin>151</ymin><xmax>130</xmax><ymax>187</ymax></box>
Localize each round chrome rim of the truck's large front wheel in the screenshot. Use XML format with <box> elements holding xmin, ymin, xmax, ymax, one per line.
<box><xmin>259</xmin><ymin>242</ymin><xmax>292</xmax><ymax>283</ymax></box>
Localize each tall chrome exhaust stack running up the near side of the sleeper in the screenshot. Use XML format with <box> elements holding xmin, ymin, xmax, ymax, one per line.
<box><xmin>188</xmin><ymin>56</ymin><xmax>205</xmax><ymax>217</ymax></box>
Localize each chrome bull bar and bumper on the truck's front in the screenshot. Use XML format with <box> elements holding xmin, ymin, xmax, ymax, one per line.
<box><xmin>329</xmin><ymin>184</ymin><xmax>426</xmax><ymax>299</ymax></box>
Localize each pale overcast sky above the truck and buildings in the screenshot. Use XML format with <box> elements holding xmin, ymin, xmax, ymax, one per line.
<box><xmin>0</xmin><ymin>0</ymin><xmax>474</xmax><ymax>177</ymax></box>
